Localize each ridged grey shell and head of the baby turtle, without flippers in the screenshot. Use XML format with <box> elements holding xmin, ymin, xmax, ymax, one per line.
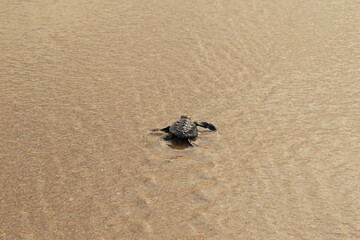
<box><xmin>169</xmin><ymin>115</ymin><xmax>198</xmax><ymax>138</ymax></box>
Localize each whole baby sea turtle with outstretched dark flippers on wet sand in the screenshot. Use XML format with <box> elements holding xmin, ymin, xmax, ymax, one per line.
<box><xmin>153</xmin><ymin>115</ymin><xmax>216</xmax><ymax>146</ymax></box>
